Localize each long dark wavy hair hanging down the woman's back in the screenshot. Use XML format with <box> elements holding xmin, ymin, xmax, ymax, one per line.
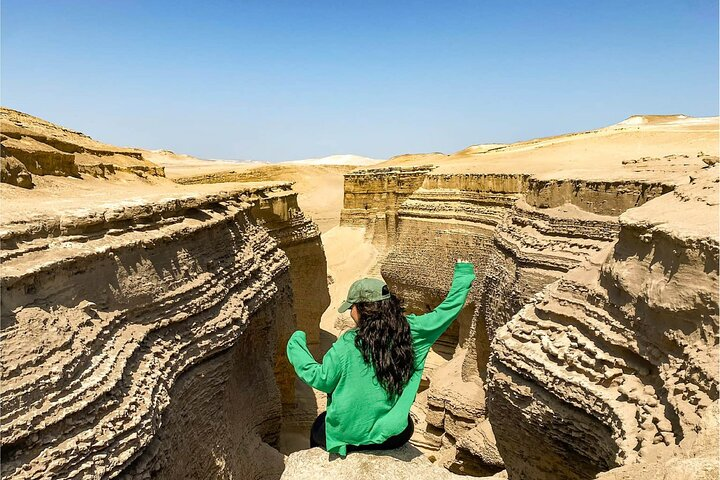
<box><xmin>355</xmin><ymin>294</ymin><xmax>415</xmax><ymax>398</ymax></box>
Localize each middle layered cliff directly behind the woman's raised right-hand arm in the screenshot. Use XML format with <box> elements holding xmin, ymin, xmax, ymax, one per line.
<box><xmin>382</xmin><ymin>174</ymin><xmax>649</xmax><ymax>474</ymax></box>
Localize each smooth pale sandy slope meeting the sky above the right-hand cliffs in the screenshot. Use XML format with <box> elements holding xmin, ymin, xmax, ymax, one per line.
<box><xmin>376</xmin><ymin>115</ymin><xmax>720</xmax><ymax>181</ymax></box>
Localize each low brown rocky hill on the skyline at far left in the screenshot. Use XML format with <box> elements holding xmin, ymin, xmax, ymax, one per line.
<box><xmin>0</xmin><ymin>107</ymin><xmax>165</xmax><ymax>188</ymax></box>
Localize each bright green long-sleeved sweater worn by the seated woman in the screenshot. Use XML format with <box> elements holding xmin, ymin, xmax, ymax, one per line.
<box><xmin>287</xmin><ymin>263</ymin><xmax>475</xmax><ymax>456</ymax></box>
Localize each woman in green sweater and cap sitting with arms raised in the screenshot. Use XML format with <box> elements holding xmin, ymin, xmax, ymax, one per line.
<box><xmin>287</xmin><ymin>260</ymin><xmax>475</xmax><ymax>456</ymax></box>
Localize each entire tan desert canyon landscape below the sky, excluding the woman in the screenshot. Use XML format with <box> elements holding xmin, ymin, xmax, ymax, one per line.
<box><xmin>0</xmin><ymin>109</ymin><xmax>720</xmax><ymax>479</ymax></box>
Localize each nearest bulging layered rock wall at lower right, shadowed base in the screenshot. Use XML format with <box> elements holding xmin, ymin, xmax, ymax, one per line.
<box><xmin>488</xmin><ymin>169</ymin><xmax>718</xmax><ymax>479</ymax></box>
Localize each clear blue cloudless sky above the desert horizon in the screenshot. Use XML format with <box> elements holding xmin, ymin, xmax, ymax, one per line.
<box><xmin>0</xmin><ymin>0</ymin><xmax>718</xmax><ymax>161</ymax></box>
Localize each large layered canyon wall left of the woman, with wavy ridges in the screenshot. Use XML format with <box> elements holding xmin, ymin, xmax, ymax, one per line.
<box><xmin>0</xmin><ymin>185</ymin><xmax>327</xmax><ymax>478</ymax></box>
